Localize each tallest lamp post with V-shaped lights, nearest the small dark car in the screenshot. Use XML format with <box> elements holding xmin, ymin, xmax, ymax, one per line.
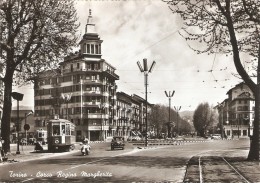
<box><xmin>137</xmin><ymin>58</ymin><xmax>156</xmax><ymax>147</ymax></box>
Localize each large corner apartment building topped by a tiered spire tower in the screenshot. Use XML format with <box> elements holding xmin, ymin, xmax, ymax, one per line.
<box><xmin>34</xmin><ymin>10</ymin><xmax>119</xmax><ymax>141</ymax></box>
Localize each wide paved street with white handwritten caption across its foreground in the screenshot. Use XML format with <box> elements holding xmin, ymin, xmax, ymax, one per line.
<box><xmin>0</xmin><ymin>140</ymin><xmax>249</xmax><ymax>182</ymax></box>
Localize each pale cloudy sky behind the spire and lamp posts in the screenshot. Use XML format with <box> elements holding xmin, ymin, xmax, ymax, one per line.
<box><xmin>17</xmin><ymin>0</ymin><xmax>241</xmax><ymax>111</ymax></box>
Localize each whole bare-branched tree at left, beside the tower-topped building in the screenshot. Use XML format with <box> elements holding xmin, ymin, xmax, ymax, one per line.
<box><xmin>0</xmin><ymin>0</ymin><xmax>79</xmax><ymax>151</ymax></box>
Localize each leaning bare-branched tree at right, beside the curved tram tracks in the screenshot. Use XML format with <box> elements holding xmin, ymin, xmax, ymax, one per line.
<box><xmin>163</xmin><ymin>0</ymin><xmax>260</xmax><ymax>160</ymax></box>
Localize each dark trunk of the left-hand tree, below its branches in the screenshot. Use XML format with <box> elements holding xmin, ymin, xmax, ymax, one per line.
<box><xmin>1</xmin><ymin>71</ymin><xmax>13</xmax><ymax>152</ymax></box>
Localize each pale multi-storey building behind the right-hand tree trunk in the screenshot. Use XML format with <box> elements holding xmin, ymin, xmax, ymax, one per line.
<box><xmin>218</xmin><ymin>83</ymin><xmax>255</xmax><ymax>138</ymax></box>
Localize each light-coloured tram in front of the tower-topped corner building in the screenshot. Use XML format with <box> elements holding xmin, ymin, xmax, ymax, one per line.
<box><xmin>47</xmin><ymin>119</ymin><xmax>76</xmax><ymax>152</ymax></box>
